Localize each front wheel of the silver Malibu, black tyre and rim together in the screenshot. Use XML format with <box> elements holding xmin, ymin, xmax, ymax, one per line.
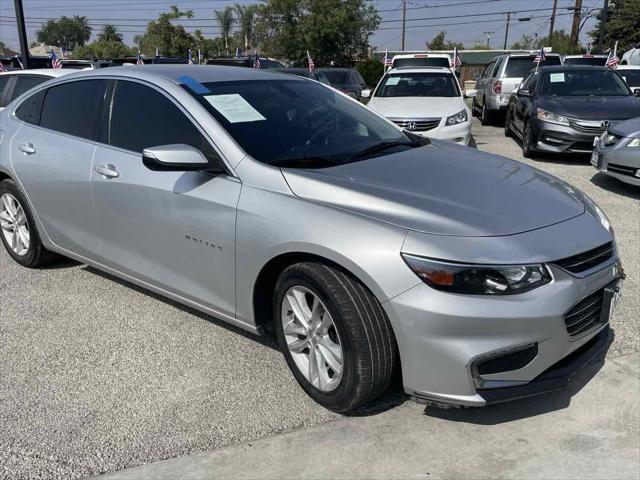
<box><xmin>274</xmin><ymin>262</ymin><xmax>398</xmax><ymax>412</ymax></box>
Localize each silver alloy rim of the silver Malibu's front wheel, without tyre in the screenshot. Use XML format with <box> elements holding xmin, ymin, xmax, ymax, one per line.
<box><xmin>281</xmin><ymin>286</ymin><xmax>344</xmax><ymax>392</ymax></box>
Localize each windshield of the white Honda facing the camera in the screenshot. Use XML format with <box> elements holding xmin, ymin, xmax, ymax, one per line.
<box><xmin>375</xmin><ymin>72</ymin><xmax>460</xmax><ymax>97</ymax></box>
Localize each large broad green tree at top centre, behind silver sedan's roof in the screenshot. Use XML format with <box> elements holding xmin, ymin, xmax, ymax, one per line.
<box><xmin>256</xmin><ymin>0</ymin><xmax>380</xmax><ymax>66</ymax></box>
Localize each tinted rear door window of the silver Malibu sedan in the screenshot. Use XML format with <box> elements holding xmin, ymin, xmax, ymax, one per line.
<box><xmin>40</xmin><ymin>80</ymin><xmax>107</xmax><ymax>141</ymax></box>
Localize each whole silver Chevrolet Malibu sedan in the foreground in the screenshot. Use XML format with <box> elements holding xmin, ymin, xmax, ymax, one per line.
<box><xmin>0</xmin><ymin>65</ymin><xmax>623</xmax><ymax>411</ymax></box>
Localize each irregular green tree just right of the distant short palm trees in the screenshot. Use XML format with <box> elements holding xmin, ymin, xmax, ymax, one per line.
<box><xmin>138</xmin><ymin>5</ymin><xmax>195</xmax><ymax>57</ymax></box>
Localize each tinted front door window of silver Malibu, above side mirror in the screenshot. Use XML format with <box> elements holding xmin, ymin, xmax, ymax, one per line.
<box><xmin>109</xmin><ymin>81</ymin><xmax>218</xmax><ymax>160</ymax></box>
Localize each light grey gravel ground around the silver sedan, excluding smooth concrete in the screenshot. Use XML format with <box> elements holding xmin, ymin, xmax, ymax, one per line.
<box><xmin>0</xmin><ymin>117</ymin><xmax>640</xmax><ymax>478</ymax></box>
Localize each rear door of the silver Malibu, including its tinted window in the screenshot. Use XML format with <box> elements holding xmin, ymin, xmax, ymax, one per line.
<box><xmin>11</xmin><ymin>80</ymin><xmax>107</xmax><ymax>258</ymax></box>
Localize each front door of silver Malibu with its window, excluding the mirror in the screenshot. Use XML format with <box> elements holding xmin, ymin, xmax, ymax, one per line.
<box><xmin>91</xmin><ymin>80</ymin><xmax>241</xmax><ymax>316</ymax></box>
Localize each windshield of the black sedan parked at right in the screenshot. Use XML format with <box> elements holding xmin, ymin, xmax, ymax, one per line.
<box><xmin>541</xmin><ymin>69</ymin><xmax>630</xmax><ymax>96</ymax></box>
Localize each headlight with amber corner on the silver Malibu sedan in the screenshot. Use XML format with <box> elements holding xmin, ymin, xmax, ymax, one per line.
<box><xmin>402</xmin><ymin>254</ymin><xmax>551</xmax><ymax>295</ymax></box>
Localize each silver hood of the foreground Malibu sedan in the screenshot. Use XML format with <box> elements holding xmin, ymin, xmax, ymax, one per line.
<box><xmin>283</xmin><ymin>141</ymin><xmax>585</xmax><ymax>237</ymax></box>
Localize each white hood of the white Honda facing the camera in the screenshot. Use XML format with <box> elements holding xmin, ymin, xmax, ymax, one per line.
<box><xmin>367</xmin><ymin>97</ymin><xmax>465</xmax><ymax>118</ymax></box>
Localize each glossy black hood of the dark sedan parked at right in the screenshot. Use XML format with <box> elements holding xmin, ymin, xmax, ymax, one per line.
<box><xmin>538</xmin><ymin>95</ymin><xmax>640</xmax><ymax>120</ymax></box>
